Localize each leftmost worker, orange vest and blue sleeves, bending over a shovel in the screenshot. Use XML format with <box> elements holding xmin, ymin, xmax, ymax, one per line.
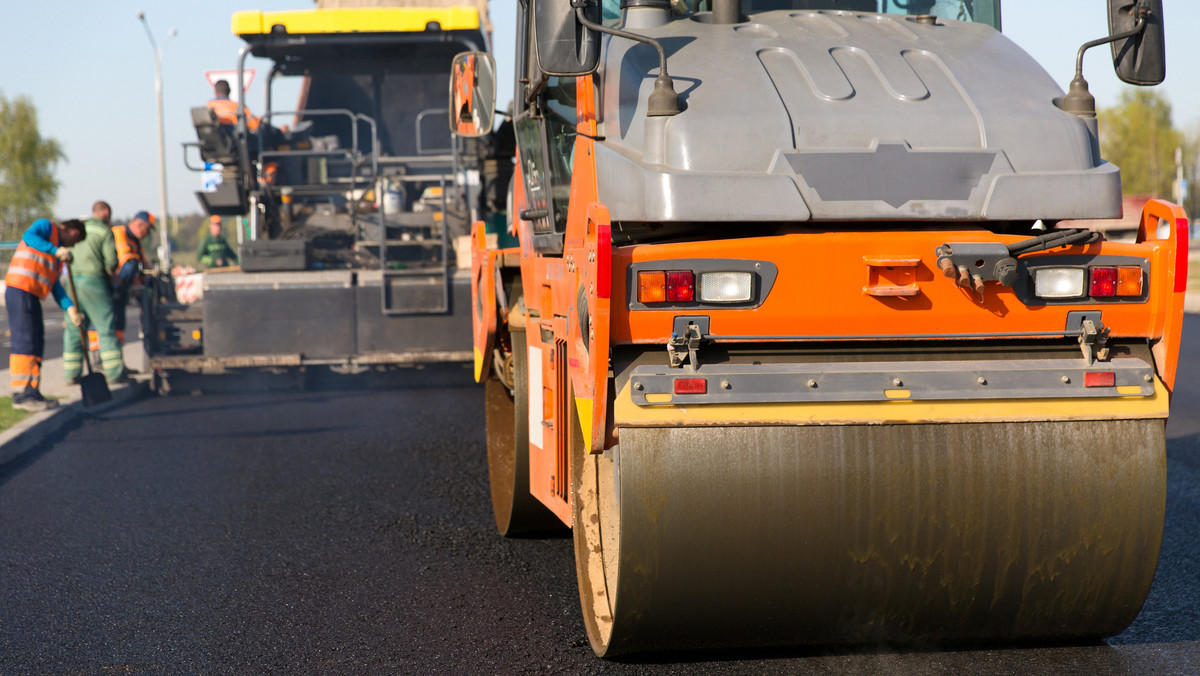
<box><xmin>4</xmin><ymin>219</ymin><xmax>86</xmax><ymax>411</ymax></box>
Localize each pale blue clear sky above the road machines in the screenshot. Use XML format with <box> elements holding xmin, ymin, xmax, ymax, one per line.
<box><xmin>0</xmin><ymin>0</ymin><xmax>1200</xmax><ymax>219</ymax></box>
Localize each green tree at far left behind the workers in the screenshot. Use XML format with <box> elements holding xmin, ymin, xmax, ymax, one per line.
<box><xmin>0</xmin><ymin>94</ymin><xmax>66</xmax><ymax>240</ymax></box>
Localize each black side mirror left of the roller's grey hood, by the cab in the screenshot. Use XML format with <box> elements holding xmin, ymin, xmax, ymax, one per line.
<box><xmin>532</xmin><ymin>0</ymin><xmax>600</xmax><ymax>77</ymax></box>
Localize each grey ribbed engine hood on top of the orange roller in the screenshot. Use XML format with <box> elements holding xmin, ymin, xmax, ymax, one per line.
<box><xmin>596</xmin><ymin>11</ymin><xmax>1120</xmax><ymax>221</ymax></box>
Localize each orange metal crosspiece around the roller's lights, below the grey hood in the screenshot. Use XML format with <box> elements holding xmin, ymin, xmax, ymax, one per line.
<box><xmin>612</xmin><ymin>229</ymin><xmax>1182</xmax><ymax>355</ymax></box>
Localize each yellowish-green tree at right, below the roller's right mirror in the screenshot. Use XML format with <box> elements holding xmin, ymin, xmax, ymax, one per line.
<box><xmin>1099</xmin><ymin>88</ymin><xmax>1183</xmax><ymax>199</ymax></box>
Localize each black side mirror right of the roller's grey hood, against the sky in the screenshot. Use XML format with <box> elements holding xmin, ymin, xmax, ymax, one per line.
<box><xmin>1109</xmin><ymin>0</ymin><xmax>1166</xmax><ymax>85</ymax></box>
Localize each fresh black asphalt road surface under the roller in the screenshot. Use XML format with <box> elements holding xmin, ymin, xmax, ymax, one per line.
<box><xmin>0</xmin><ymin>317</ymin><xmax>1200</xmax><ymax>675</ymax></box>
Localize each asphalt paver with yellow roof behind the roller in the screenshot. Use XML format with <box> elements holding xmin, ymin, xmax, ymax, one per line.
<box><xmin>144</xmin><ymin>5</ymin><xmax>488</xmax><ymax>386</ymax></box>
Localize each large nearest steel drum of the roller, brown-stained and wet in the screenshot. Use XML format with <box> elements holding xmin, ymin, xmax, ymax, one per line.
<box><xmin>574</xmin><ymin>419</ymin><xmax>1166</xmax><ymax>656</ymax></box>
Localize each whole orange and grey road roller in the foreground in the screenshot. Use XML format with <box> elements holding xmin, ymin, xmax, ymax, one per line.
<box><xmin>451</xmin><ymin>0</ymin><xmax>1187</xmax><ymax>656</ymax></box>
